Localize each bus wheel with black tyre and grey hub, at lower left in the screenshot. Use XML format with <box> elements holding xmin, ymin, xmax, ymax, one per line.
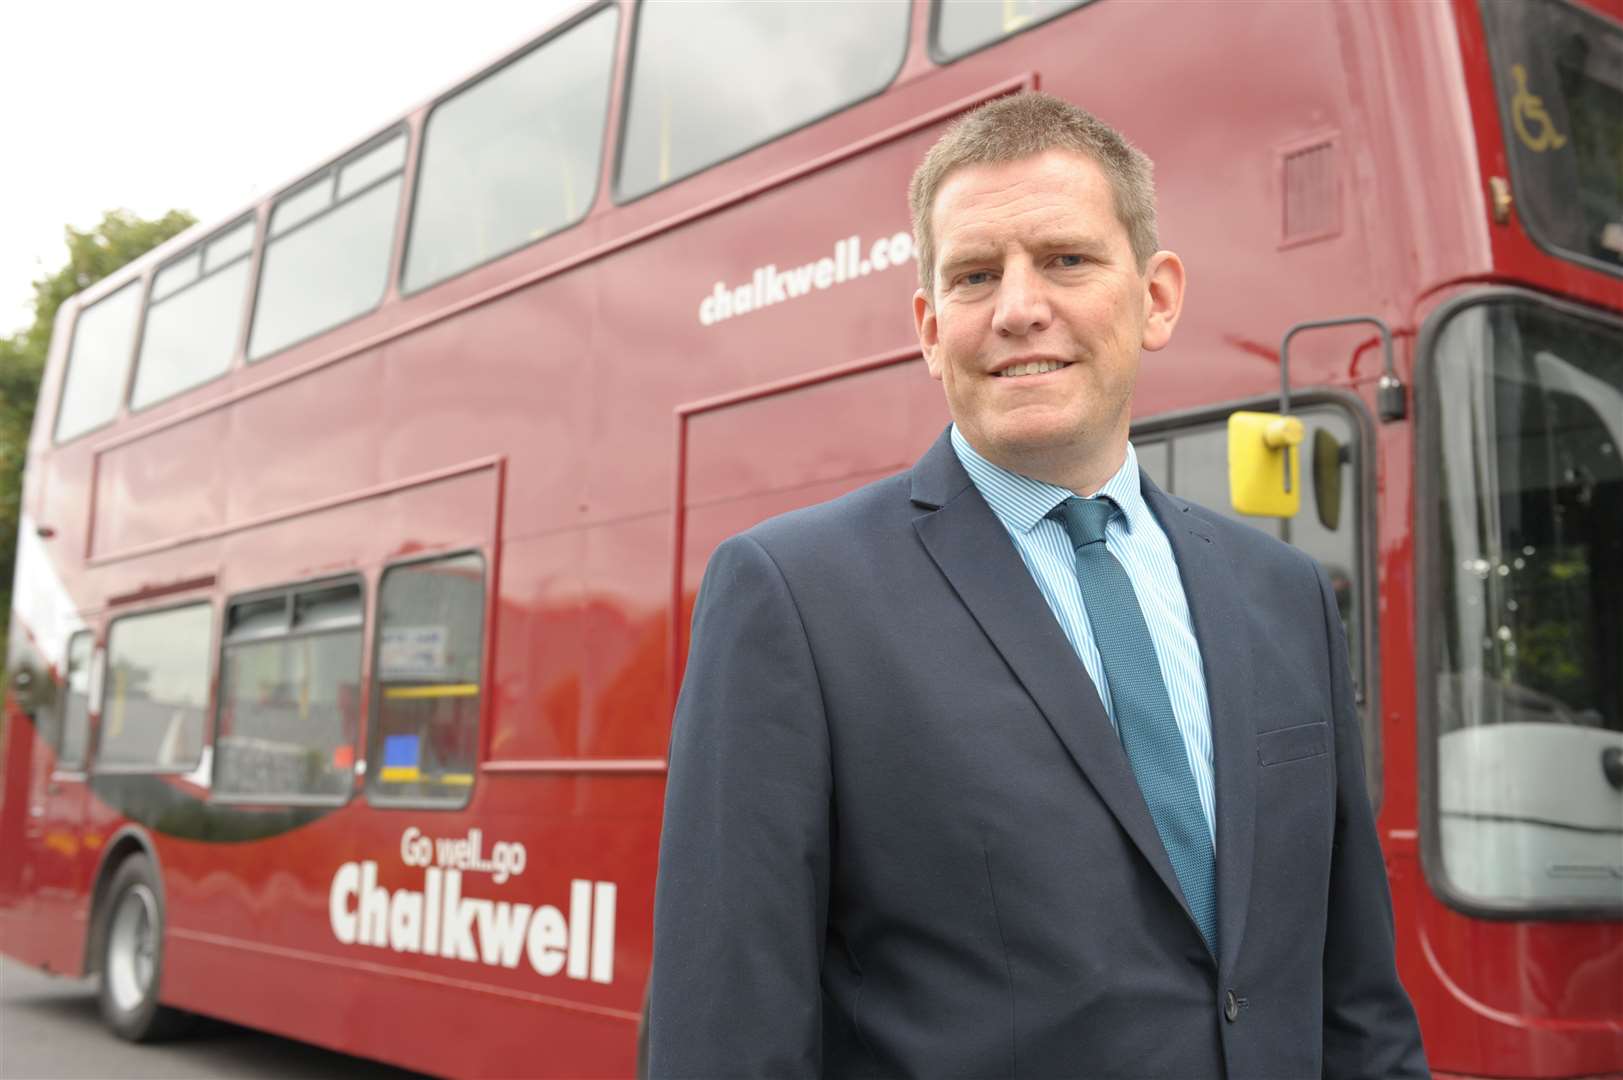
<box><xmin>101</xmin><ymin>856</ymin><xmax>192</xmax><ymax>1043</ymax></box>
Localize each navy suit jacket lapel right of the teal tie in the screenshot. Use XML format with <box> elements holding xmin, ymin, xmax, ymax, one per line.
<box><xmin>1143</xmin><ymin>476</ymin><xmax>1256</xmax><ymax>971</ymax></box>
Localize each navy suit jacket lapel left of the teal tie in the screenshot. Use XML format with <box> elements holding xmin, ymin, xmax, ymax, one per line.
<box><xmin>912</xmin><ymin>435</ymin><xmax>1188</xmax><ymax>911</ymax></box>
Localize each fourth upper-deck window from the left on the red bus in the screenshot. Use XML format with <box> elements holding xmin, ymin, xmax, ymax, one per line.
<box><xmin>404</xmin><ymin>8</ymin><xmax>620</xmax><ymax>291</ymax></box>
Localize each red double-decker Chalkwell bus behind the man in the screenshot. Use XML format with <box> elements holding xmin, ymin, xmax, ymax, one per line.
<box><xmin>0</xmin><ymin>0</ymin><xmax>1623</xmax><ymax>1077</ymax></box>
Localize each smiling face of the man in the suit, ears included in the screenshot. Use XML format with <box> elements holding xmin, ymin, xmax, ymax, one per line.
<box><xmin>914</xmin><ymin>151</ymin><xmax>1183</xmax><ymax>482</ymax></box>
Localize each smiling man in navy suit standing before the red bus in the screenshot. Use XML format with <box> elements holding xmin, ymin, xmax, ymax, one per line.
<box><xmin>649</xmin><ymin>94</ymin><xmax>1427</xmax><ymax>1078</ymax></box>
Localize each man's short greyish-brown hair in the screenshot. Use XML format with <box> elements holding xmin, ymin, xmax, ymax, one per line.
<box><xmin>907</xmin><ymin>91</ymin><xmax>1159</xmax><ymax>297</ymax></box>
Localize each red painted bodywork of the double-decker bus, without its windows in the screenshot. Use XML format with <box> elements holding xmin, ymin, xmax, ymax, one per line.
<box><xmin>0</xmin><ymin>0</ymin><xmax>1623</xmax><ymax>1077</ymax></box>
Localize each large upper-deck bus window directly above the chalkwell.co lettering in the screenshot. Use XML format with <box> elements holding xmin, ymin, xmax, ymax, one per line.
<box><xmin>617</xmin><ymin>0</ymin><xmax>909</xmax><ymax>200</ymax></box>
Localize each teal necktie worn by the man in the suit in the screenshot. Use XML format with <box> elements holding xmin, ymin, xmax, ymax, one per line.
<box><xmin>1050</xmin><ymin>497</ymin><xmax>1217</xmax><ymax>957</ymax></box>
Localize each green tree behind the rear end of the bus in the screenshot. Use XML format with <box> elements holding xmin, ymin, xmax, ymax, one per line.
<box><xmin>0</xmin><ymin>210</ymin><xmax>196</xmax><ymax>656</ymax></box>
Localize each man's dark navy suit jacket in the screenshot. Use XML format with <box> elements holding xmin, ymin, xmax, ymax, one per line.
<box><xmin>648</xmin><ymin>435</ymin><xmax>1427</xmax><ymax>1080</ymax></box>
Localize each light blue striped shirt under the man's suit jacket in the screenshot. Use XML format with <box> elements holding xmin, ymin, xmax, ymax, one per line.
<box><xmin>953</xmin><ymin>424</ymin><xmax>1217</xmax><ymax>849</ymax></box>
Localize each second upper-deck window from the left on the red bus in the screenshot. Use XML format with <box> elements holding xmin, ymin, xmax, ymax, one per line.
<box><xmin>130</xmin><ymin>221</ymin><xmax>253</xmax><ymax>409</ymax></box>
